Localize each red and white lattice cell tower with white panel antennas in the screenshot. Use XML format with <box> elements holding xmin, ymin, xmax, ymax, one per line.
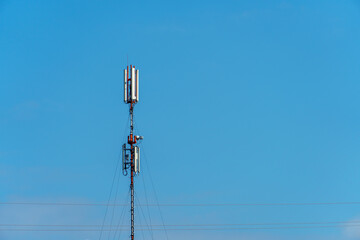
<box><xmin>122</xmin><ymin>65</ymin><xmax>143</xmax><ymax>240</ymax></box>
